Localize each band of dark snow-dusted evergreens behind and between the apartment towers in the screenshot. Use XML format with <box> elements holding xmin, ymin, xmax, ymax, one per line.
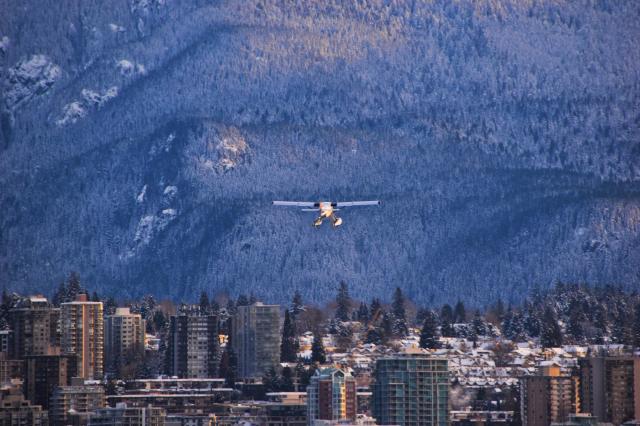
<box><xmin>0</xmin><ymin>272</ymin><xmax>640</xmax><ymax>390</ymax></box>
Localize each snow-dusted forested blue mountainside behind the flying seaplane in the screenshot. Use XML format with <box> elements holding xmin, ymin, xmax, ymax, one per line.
<box><xmin>0</xmin><ymin>0</ymin><xmax>640</xmax><ymax>303</ymax></box>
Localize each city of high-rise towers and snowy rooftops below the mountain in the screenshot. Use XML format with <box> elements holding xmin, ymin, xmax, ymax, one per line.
<box><xmin>0</xmin><ymin>280</ymin><xmax>640</xmax><ymax>426</ymax></box>
